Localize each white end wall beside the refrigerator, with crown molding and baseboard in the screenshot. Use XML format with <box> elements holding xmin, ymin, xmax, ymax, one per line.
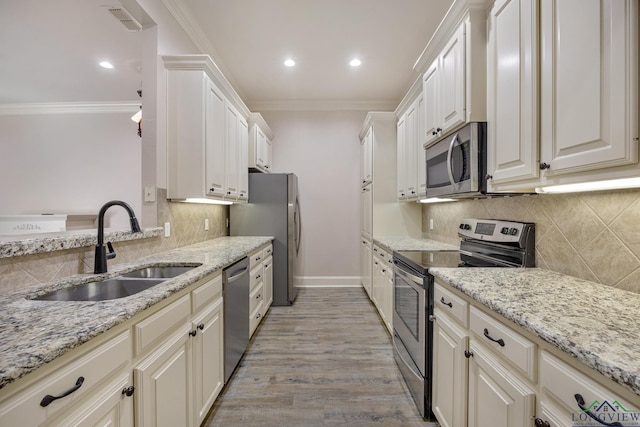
<box><xmin>262</xmin><ymin>111</ymin><xmax>366</xmax><ymax>285</ymax></box>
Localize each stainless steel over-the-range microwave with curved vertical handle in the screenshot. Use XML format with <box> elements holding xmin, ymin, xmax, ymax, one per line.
<box><xmin>425</xmin><ymin>122</ymin><xmax>487</xmax><ymax>198</ymax></box>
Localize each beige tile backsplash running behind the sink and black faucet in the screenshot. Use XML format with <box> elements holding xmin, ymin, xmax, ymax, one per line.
<box><xmin>0</xmin><ymin>189</ymin><xmax>229</xmax><ymax>295</ymax></box>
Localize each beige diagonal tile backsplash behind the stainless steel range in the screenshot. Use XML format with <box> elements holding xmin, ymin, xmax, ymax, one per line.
<box><xmin>422</xmin><ymin>190</ymin><xmax>640</xmax><ymax>293</ymax></box>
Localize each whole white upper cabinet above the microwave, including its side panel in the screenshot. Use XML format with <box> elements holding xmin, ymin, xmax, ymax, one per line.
<box><xmin>419</xmin><ymin>7</ymin><xmax>486</xmax><ymax>148</ymax></box>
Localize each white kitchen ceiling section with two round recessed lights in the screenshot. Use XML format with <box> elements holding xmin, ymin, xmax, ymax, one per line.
<box><xmin>174</xmin><ymin>0</ymin><xmax>453</xmax><ymax>111</ymax></box>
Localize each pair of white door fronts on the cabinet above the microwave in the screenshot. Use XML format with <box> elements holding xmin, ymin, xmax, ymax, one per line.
<box><xmin>423</xmin><ymin>24</ymin><xmax>466</xmax><ymax>143</ymax></box>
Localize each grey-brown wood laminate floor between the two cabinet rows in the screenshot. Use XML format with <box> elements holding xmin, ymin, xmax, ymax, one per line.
<box><xmin>203</xmin><ymin>288</ymin><xmax>431</xmax><ymax>427</ymax></box>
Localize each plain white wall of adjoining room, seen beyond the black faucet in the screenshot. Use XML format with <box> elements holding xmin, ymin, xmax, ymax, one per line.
<box><xmin>0</xmin><ymin>113</ymin><xmax>141</xmax><ymax>228</ymax></box>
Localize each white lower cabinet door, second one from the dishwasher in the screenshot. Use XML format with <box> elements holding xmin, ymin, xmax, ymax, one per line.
<box><xmin>133</xmin><ymin>323</ymin><xmax>193</xmax><ymax>427</ymax></box>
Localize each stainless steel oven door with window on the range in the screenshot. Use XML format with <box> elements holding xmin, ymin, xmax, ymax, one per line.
<box><xmin>393</xmin><ymin>260</ymin><xmax>426</xmax><ymax>378</ymax></box>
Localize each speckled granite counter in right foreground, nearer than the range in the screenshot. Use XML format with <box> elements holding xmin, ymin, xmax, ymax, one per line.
<box><xmin>430</xmin><ymin>268</ymin><xmax>640</xmax><ymax>395</ymax></box>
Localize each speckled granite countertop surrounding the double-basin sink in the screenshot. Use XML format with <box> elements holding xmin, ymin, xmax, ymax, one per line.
<box><xmin>0</xmin><ymin>237</ymin><xmax>273</xmax><ymax>389</ymax></box>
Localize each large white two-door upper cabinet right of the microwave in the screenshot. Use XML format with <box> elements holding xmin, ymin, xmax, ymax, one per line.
<box><xmin>487</xmin><ymin>0</ymin><xmax>640</xmax><ymax>191</ymax></box>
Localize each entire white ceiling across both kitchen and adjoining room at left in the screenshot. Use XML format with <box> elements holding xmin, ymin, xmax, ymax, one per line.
<box><xmin>0</xmin><ymin>0</ymin><xmax>453</xmax><ymax>111</ymax></box>
